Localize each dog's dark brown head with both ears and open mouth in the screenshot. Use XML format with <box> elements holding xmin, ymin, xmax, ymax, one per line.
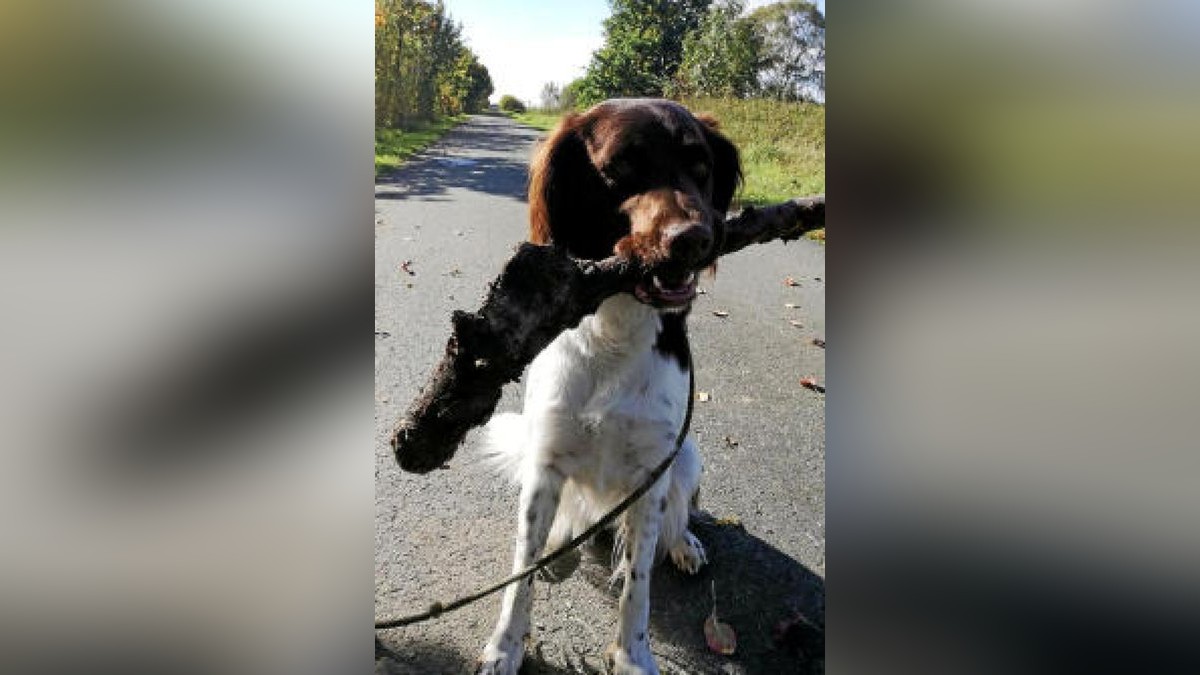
<box><xmin>529</xmin><ymin>98</ymin><xmax>742</xmax><ymax>309</ymax></box>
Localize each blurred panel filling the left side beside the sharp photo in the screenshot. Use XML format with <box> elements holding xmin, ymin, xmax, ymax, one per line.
<box><xmin>0</xmin><ymin>0</ymin><xmax>373</xmax><ymax>673</ymax></box>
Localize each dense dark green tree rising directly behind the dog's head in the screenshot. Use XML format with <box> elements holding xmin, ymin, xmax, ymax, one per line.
<box><xmin>578</xmin><ymin>0</ymin><xmax>712</xmax><ymax>104</ymax></box>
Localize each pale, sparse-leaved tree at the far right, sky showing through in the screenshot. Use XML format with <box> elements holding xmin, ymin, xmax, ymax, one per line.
<box><xmin>750</xmin><ymin>0</ymin><xmax>824</xmax><ymax>103</ymax></box>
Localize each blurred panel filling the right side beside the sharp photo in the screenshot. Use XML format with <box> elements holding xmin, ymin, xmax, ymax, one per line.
<box><xmin>827</xmin><ymin>0</ymin><xmax>1200</xmax><ymax>674</ymax></box>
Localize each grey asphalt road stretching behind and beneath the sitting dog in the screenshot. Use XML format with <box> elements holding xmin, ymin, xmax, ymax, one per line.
<box><xmin>374</xmin><ymin>115</ymin><xmax>824</xmax><ymax>674</ymax></box>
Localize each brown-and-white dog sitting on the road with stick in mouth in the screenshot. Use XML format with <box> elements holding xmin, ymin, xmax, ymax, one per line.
<box><xmin>476</xmin><ymin>98</ymin><xmax>742</xmax><ymax>675</ymax></box>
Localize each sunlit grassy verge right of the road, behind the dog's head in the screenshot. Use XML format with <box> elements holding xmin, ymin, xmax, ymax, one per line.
<box><xmin>509</xmin><ymin>98</ymin><xmax>826</xmax><ymax>241</ymax></box>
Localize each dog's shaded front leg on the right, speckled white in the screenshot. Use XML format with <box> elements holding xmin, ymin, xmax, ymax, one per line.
<box><xmin>607</xmin><ymin>480</ymin><xmax>667</xmax><ymax>675</ymax></box>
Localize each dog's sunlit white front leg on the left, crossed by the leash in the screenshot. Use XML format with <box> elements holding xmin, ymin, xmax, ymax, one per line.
<box><xmin>478</xmin><ymin>466</ymin><xmax>563</xmax><ymax>675</ymax></box>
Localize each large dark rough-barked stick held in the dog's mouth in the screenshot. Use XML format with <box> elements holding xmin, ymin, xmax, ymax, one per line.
<box><xmin>391</xmin><ymin>195</ymin><xmax>824</xmax><ymax>473</ymax></box>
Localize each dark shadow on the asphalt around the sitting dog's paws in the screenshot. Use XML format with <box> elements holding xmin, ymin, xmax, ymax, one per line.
<box><xmin>376</xmin><ymin>513</ymin><xmax>824</xmax><ymax>675</ymax></box>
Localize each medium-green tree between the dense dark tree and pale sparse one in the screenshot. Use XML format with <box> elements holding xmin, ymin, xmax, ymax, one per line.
<box><xmin>670</xmin><ymin>0</ymin><xmax>762</xmax><ymax>98</ymax></box>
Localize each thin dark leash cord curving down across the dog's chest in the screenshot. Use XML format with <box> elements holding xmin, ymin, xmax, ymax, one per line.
<box><xmin>376</xmin><ymin>344</ymin><xmax>696</xmax><ymax>631</ymax></box>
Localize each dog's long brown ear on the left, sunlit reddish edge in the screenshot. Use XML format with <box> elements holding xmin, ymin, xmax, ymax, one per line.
<box><xmin>529</xmin><ymin>113</ymin><xmax>620</xmax><ymax>259</ymax></box>
